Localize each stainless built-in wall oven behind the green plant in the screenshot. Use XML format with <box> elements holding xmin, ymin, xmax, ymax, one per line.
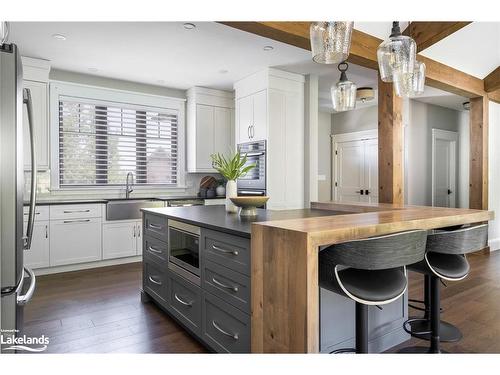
<box><xmin>238</xmin><ymin>141</ymin><xmax>266</xmax><ymax>195</ymax></box>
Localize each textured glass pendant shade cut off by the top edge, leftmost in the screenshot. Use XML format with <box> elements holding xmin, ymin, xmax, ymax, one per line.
<box><xmin>310</xmin><ymin>21</ymin><xmax>354</xmax><ymax>64</ymax></box>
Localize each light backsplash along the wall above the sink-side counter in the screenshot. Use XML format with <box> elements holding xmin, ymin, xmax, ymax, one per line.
<box><xmin>24</xmin><ymin>170</ymin><xmax>221</xmax><ymax>198</ymax></box>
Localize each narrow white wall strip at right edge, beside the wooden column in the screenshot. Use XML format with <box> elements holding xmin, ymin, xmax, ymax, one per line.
<box><xmin>488</xmin><ymin>102</ymin><xmax>500</xmax><ymax>250</ymax></box>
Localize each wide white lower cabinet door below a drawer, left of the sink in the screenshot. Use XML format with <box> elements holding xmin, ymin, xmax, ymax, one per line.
<box><xmin>50</xmin><ymin>218</ymin><xmax>102</xmax><ymax>266</ymax></box>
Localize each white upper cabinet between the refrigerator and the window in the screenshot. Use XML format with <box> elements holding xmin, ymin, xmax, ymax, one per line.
<box><xmin>22</xmin><ymin>57</ymin><xmax>50</xmax><ymax>170</ymax></box>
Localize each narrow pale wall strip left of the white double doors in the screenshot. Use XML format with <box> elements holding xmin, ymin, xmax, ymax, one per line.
<box><xmin>318</xmin><ymin>112</ymin><xmax>332</xmax><ymax>201</ymax></box>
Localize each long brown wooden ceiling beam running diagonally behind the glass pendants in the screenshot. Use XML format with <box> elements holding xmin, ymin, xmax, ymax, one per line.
<box><xmin>221</xmin><ymin>22</ymin><xmax>486</xmax><ymax>98</ymax></box>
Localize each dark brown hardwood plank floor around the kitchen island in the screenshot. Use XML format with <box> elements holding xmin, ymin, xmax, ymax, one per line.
<box><xmin>24</xmin><ymin>252</ymin><xmax>500</xmax><ymax>353</ymax></box>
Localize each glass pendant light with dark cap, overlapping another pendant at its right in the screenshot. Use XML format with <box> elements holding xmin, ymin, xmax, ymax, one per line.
<box><xmin>377</xmin><ymin>21</ymin><xmax>417</xmax><ymax>82</ymax></box>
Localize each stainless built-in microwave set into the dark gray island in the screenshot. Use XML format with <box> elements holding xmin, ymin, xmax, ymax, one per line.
<box><xmin>168</xmin><ymin>220</ymin><xmax>200</xmax><ymax>285</ymax></box>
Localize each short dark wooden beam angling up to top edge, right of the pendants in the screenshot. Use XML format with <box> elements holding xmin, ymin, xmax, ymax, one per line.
<box><xmin>403</xmin><ymin>21</ymin><xmax>471</xmax><ymax>53</ymax></box>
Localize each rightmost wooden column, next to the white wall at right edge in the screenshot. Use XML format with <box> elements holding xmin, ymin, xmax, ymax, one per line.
<box><xmin>469</xmin><ymin>96</ymin><xmax>489</xmax><ymax>210</ymax></box>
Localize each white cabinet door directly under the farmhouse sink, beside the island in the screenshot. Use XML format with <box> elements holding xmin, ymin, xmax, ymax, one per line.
<box><xmin>102</xmin><ymin>221</ymin><xmax>137</xmax><ymax>259</ymax></box>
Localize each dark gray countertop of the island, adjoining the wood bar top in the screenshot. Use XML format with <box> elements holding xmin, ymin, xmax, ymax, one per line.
<box><xmin>142</xmin><ymin>205</ymin><xmax>346</xmax><ymax>238</ymax></box>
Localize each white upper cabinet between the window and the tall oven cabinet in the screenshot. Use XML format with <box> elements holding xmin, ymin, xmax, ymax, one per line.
<box><xmin>187</xmin><ymin>87</ymin><xmax>234</xmax><ymax>173</ymax></box>
